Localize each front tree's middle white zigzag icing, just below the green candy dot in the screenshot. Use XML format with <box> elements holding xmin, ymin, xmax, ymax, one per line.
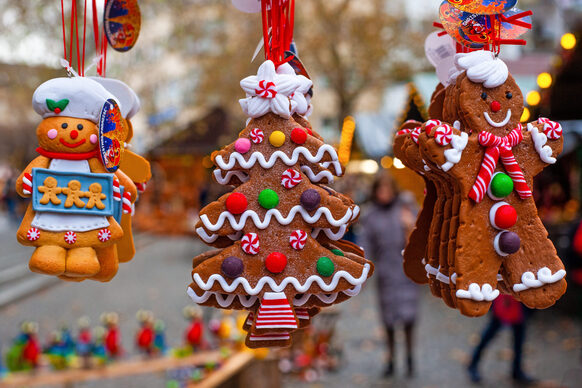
<box><xmin>200</xmin><ymin>205</ymin><xmax>360</xmax><ymax>232</ymax></box>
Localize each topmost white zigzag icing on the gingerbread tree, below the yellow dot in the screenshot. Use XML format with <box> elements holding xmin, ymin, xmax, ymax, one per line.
<box><xmin>214</xmin><ymin>144</ymin><xmax>341</xmax><ymax>175</ymax></box>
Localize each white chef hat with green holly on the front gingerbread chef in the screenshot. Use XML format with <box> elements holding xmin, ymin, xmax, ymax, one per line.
<box><xmin>32</xmin><ymin>77</ymin><xmax>117</xmax><ymax>123</ymax></box>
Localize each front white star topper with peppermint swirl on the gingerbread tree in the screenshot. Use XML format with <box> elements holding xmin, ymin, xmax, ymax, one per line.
<box><xmin>239</xmin><ymin>60</ymin><xmax>300</xmax><ymax>118</ymax></box>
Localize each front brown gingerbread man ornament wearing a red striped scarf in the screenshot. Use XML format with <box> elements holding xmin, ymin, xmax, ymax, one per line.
<box><xmin>419</xmin><ymin>51</ymin><xmax>566</xmax><ymax>316</ymax></box>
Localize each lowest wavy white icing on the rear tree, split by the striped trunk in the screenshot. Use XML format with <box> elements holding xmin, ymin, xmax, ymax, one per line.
<box><xmin>187</xmin><ymin>284</ymin><xmax>362</xmax><ymax>308</ymax></box>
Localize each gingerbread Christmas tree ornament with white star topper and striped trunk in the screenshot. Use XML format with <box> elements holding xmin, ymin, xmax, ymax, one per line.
<box><xmin>188</xmin><ymin>4</ymin><xmax>373</xmax><ymax>347</ymax></box>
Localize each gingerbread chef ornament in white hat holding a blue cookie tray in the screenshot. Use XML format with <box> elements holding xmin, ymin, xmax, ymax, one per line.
<box><xmin>16</xmin><ymin>76</ymin><xmax>135</xmax><ymax>281</ymax></box>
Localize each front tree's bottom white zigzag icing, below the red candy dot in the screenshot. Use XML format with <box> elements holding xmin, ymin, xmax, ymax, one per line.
<box><xmin>192</xmin><ymin>264</ymin><xmax>370</xmax><ymax>295</ymax></box>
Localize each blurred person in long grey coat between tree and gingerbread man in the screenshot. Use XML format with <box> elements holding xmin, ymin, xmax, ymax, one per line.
<box><xmin>359</xmin><ymin>173</ymin><xmax>419</xmax><ymax>377</ymax></box>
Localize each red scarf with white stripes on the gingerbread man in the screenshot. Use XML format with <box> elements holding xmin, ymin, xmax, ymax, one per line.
<box><xmin>469</xmin><ymin>124</ymin><xmax>532</xmax><ymax>203</ymax></box>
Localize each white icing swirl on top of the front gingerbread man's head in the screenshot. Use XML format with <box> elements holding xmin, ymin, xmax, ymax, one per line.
<box><xmin>455</xmin><ymin>50</ymin><xmax>509</xmax><ymax>89</ymax></box>
